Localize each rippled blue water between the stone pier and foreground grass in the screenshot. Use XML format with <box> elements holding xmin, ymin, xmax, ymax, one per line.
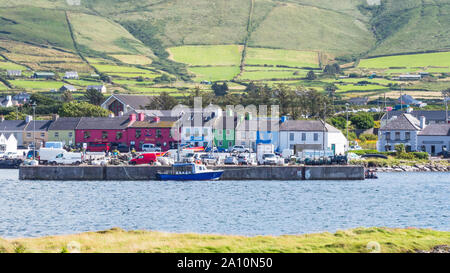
<box><xmin>0</xmin><ymin>170</ymin><xmax>450</xmax><ymax>237</ymax></box>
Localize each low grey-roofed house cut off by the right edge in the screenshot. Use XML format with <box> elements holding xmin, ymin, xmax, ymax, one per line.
<box><xmin>418</xmin><ymin>124</ymin><xmax>450</xmax><ymax>155</ymax></box>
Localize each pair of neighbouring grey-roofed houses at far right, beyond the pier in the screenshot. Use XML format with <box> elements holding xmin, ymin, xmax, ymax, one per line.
<box><xmin>377</xmin><ymin>110</ymin><xmax>450</xmax><ymax>155</ymax></box>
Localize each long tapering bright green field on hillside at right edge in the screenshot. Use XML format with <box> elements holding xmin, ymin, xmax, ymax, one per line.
<box><xmin>359</xmin><ymin>52</ymin><xmax>450</xmax><ymax>69</ymax></box>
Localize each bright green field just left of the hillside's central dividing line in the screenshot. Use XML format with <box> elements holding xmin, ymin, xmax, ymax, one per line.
<box><xmin>168</xmin><ymin>45</ymin><xmax>242</xmax><ymax>66</ymax></box>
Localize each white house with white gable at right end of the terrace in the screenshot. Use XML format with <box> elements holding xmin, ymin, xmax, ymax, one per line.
<box><xmin>279</xmin><ymin>120</ymin><xmax>348</xmax><ymax>154</ymax></box>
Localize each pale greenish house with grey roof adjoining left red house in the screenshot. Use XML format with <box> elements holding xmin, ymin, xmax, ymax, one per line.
<box><xmin>48</xmin><ymin>115</ymin><xmax>81</xmax><ymax>145</ymax></box>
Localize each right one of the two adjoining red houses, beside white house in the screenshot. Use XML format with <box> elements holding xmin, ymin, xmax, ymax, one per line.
<box><xmin>127</xmin><ymin>113</ymin><xmax>178</xmax><ymax>151</ymax></box>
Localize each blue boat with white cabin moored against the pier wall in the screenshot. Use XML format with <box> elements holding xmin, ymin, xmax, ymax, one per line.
<box><xmin>156</xmin><ymin>163</ymin><xmax>223</xmax><ymax>181</ymax></box>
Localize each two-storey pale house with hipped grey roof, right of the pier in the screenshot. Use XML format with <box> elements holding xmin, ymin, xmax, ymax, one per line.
<box><xmin>377</xmin><ymin>114</ymin><xmax>426</xmax><ymax>152</ymax></box>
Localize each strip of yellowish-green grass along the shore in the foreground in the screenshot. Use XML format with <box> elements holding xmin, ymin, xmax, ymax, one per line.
<box><xmin>0</xmin><ymin>228</ymin><xmax>450</xmax><ymax>253</ymax></box>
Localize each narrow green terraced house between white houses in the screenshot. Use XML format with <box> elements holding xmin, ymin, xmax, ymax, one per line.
<box><xmin>213</xmin><ymin>116</ymin><xmax>237</xmax><ymax>149</ymax></box>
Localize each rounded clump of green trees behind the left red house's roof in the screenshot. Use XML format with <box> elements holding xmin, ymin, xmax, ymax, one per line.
<box><xmin>58</xmin><ymin>101</ymin><xmax>110</xmax><ymax>117</ymax></box>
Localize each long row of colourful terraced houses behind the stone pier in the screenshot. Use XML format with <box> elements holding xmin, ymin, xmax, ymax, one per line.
<box><xmin>0</xmin><ymin>95</ymin><xmax>348</xmax><ymax>154</ymax></box>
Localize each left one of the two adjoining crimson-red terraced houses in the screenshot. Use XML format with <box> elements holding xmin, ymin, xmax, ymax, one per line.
<box><xmin>75</xmin><ymin>114</ymin><xmax>136</xmax><ymax>151</ymax></box>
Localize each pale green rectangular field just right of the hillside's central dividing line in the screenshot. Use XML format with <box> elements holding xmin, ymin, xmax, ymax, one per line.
<box><xmin>245</xmin><ymin>47</ymin><xmax>319</xmax><ymax>68</ymax></box>
